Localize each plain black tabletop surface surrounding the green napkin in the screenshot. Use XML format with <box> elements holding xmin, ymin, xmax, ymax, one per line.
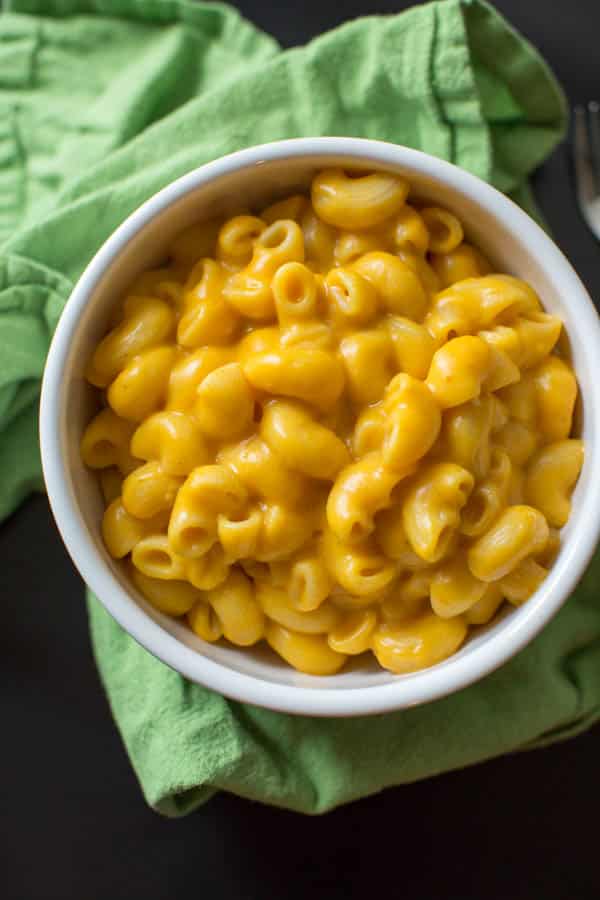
<box><xmin>0</xmin><ymin>0</ymin><xmax>600</xmax><ymax>900</ymax></box>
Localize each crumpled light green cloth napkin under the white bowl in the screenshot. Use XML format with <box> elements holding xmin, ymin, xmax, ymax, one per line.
<box><xmin>0</xmin><ymin>0</ymin><xmax>600</xmax><ymax>816</ymax></box>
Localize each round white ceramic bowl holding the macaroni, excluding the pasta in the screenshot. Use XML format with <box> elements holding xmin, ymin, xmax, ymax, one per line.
<box><xmin>40</xmin><ymin>138</ymin><xmax>600</xmax><ymax>716</ymax></box>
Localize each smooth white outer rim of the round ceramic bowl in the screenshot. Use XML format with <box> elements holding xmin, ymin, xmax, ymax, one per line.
<box><xmin>40</xmin><ymin>137</ymin><xmax>600</xmax><ymax>716</ymax></box>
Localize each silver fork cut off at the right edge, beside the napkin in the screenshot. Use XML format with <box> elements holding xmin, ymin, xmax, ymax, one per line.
<box><xmin>573</xmin><ymin>100</ymin><xmax>600</xmax><ymax>240</ymax></box>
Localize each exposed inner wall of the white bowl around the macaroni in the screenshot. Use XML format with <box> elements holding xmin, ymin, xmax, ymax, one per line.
<box><xmin>59</xmin><ymin>153</ymin><xmax>594</xmax><ymax>691</ymax></box>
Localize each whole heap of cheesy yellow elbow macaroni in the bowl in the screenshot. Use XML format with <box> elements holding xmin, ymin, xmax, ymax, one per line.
<box><xmin>81</xmin><ymin>169</ymin><xmax>584</xmax><ymax>675</ymax></box>
